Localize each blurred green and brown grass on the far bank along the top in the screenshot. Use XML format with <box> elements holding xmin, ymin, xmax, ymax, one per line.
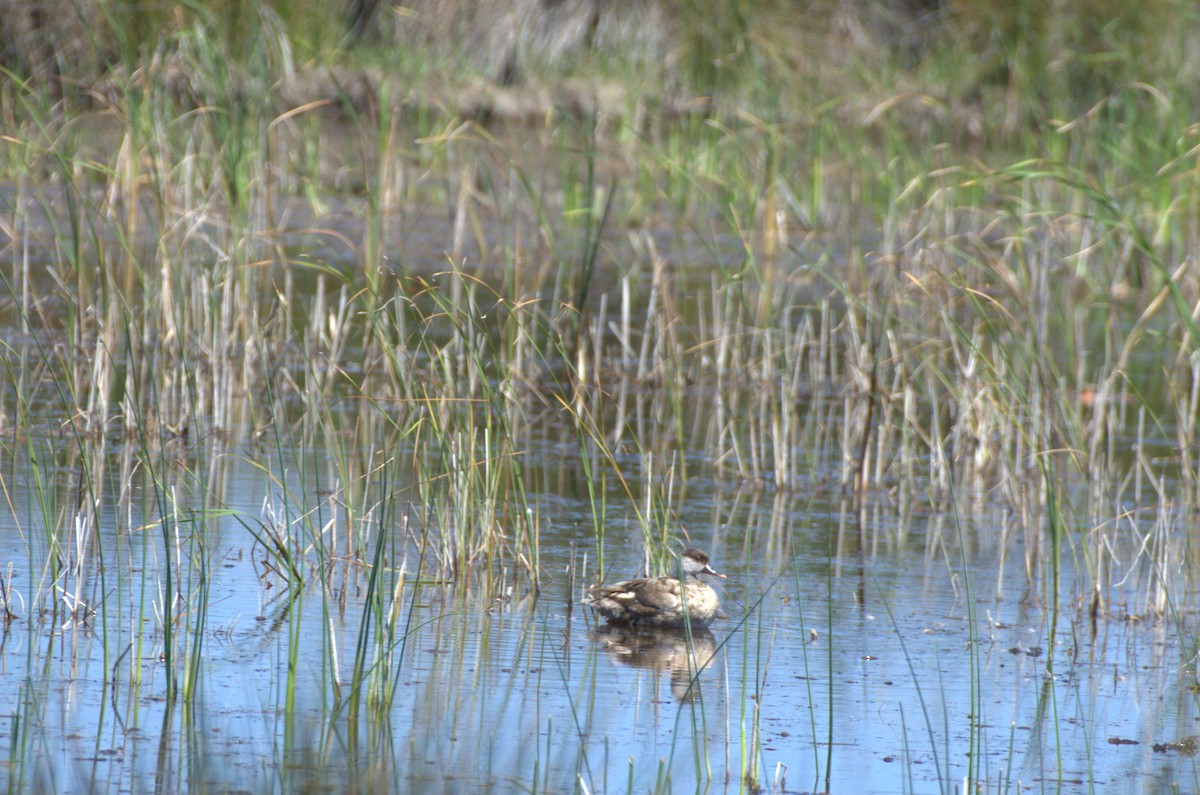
<box><xmin>0</xmin><ymin>0</ymin><xmax>1200</xmax><ymax>151</ymax></box>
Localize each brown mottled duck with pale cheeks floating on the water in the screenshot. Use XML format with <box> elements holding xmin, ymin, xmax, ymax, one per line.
<box><xmin>584</xmin><ymin>548</ymin><xmax>725</xmax><ymax>629</ymax></box>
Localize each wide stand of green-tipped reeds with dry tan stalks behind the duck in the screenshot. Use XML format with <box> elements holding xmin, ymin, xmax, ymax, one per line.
<box><xmin>6</xmin><ymin>0</ymin><xmax>1198</xmax><ymax>643</ymax></box>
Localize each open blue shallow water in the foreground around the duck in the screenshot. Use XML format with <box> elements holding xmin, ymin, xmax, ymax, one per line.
<box><xmin>0</xmin><ymin>444</ymin><xmax>1200</xmax><ymax>793</ymax></box>
